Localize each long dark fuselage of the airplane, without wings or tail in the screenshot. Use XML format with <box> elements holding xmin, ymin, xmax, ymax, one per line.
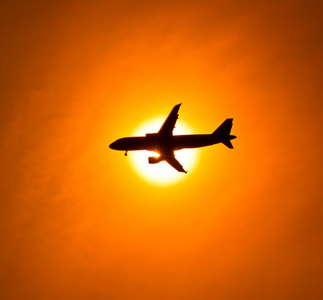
<box><xmin>110</xmin><ymin>133</ymin><xmax>220</xmax><ymax>152</ymax></box>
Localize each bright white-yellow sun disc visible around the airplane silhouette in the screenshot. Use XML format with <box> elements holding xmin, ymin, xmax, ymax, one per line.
<box><xmin>128</xmin><ymin>116</ymin><xmax>199</xmax><ymax>186</ymax></box>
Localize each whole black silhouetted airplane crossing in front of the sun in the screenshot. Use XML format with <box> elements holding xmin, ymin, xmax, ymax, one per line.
<box><xmin>109</xmin><ymin>103</ymin><xmax>236</xmax><ymax>173</ymax></box>
